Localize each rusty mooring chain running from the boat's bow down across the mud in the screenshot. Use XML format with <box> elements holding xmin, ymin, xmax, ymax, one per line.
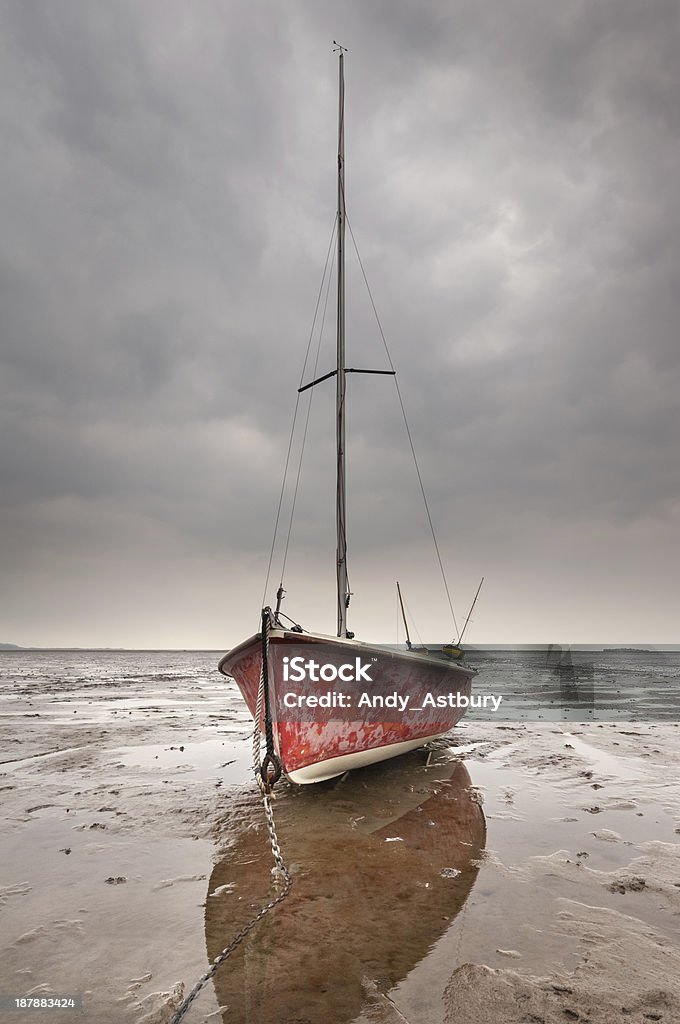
<box><xmin>170</xmin><ymin>608</ymin><xmax>293</xmax><ymax>1024</ymax></box>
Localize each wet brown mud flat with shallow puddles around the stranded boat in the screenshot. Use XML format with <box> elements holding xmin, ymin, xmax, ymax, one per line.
<box><xmin>0</xmin><ymin>652</ymin><xmax>680</xmax><ymax>1024</ymax></box>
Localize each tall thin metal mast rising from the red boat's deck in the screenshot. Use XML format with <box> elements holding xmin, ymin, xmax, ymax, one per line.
<box><xmin>336</xmin><ymin>47</ymin><xmax>349</xmax><ymax>637</ymax></box>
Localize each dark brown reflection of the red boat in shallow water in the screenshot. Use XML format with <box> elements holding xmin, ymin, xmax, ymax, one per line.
<box><xmin>206</xmin><ymin>750</ymin><xmax>485</xmax><ymax>1024</ymax></box>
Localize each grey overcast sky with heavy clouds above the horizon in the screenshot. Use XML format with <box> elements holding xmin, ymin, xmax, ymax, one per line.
<box><xmin>0</xmin><ymin>0</ymin><xmax>680</xmax><ymax>648</ymax></box>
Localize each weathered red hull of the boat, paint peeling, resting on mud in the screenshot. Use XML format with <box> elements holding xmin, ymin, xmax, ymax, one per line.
<box><xmin>219</xmin><ymin>629</ymin><xmax>474</xmax><ymax>783</ymax></box>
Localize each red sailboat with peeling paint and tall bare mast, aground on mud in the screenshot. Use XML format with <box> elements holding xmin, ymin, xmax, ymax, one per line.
<box><xmin>219</xmin><ymin>47</ymin><xmax>476</xmax><ymax>785</ymax></box>
